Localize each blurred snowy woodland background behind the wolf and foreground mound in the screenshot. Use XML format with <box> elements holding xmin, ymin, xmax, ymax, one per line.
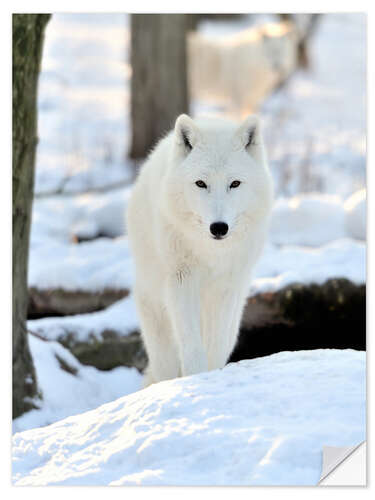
<box><xmin>14</xmin><ymin>13</ymin><xmax>366</xmax><ymax>430</ymax></box>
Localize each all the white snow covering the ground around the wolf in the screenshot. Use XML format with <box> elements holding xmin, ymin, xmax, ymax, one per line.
<box><xmin>14</xmin><ymin>14</ymin><xmax>366</xmax><ymax>484</ymax></box>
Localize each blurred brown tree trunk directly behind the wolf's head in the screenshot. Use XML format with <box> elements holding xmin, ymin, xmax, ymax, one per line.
<box><xmin>130</xmin><ymin>14</ymin><xmax>189</xmax><ymax>158</ymax></box>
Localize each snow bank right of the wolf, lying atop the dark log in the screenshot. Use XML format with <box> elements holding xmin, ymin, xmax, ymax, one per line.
<box><xmin>250</xmin><ymin>190</ymin><xmax>366</xmax><ymax>295</ymax></box>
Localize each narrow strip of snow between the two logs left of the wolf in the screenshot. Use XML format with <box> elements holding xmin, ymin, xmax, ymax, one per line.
<box><xmin>27</xmin><ymin>295</ymin><xmax>140</xmax><ymax>342</ymax></box>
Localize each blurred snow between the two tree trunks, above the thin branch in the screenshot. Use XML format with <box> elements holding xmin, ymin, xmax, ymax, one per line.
<box><xmin>35</xmin><ymin>13</ymin><xmax>132</xmax><ymax>194</ymax></box>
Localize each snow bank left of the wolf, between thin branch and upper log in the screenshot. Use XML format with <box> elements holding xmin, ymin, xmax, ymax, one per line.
<box><xmin>28</xmin><ymin>188</ymin><xmax>133</xmax><ymax>291</ymax></box>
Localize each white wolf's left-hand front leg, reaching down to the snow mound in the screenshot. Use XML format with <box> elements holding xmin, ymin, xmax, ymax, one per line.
<box><xmin>167</xmin><ymin>273</ymin><xmax>208</xmax><ymax>376</ymax></box>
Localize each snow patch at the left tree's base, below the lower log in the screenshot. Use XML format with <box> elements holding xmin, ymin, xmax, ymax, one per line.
<box><xmin>13</xmin><ymin>335</ymin><xmax>142</xmax><ymax>432</ymax></box>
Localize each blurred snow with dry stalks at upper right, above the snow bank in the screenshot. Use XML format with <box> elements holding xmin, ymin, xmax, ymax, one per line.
<box><xmin>260</xmin><ymin>13</ymin><xmax>367</xmax><ymax>198</ymax></box>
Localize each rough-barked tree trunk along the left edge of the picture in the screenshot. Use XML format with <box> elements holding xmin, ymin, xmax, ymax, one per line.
<box><xmin>13</xmin><ymin>14</ymin><xmax>50</xmax><ymax>418</ymax></box>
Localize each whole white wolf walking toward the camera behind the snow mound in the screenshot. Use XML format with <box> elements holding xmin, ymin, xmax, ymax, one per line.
<box><xmin>127</xmin><ymin>115</ymin><xmax>273</xmax><ymax>385</ymax></box>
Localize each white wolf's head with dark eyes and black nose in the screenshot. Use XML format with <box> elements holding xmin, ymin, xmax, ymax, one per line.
<box><xmin>165</xmin><ymin>115</ymin><xmax>272</xmax><ymax>245</ymax></box>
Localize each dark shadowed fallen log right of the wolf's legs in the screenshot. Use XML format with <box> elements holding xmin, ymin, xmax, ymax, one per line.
<box><xmin>230</xmin><ymin>279</ymin><xmax>366</xmax><ymax>361</ymax></box>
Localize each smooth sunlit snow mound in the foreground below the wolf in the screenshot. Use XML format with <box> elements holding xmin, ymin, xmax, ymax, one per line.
<box><xmin>13</xmin><ymin>350</ymin><xmax>366</xmax><ymax>486</ymax></box>
